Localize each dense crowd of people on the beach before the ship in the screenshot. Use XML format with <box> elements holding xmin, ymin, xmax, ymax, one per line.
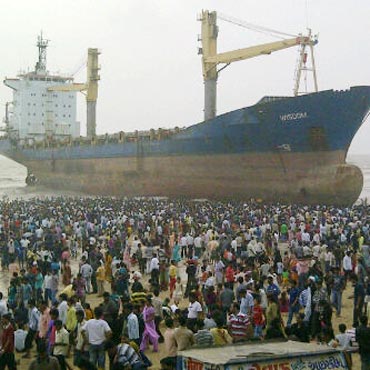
<box><xmin>0</xmin><ymin>197</ymin><xmax>370</xmax><ymax>370</ymax></box>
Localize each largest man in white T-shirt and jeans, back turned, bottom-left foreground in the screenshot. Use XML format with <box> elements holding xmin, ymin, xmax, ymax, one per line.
<box><xmin>81</xmin><ymin>307</ymin><xmax>112</xmax><ymax>369</ymax></box>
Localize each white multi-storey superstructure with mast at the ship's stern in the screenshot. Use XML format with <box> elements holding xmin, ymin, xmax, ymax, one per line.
<box><xmin>4</xmin><ymin>36</ymin><xmax>80</xmax><ymax>143</ymax></box>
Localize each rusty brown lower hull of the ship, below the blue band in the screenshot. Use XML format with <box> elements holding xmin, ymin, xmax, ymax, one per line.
<box><xmin>22</xmin><ymin>150</ymin><xmax>363</xmax><ymax>205</ymax></box>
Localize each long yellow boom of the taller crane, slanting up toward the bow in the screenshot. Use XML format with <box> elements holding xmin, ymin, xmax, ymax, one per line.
<box><xmin>204</xmin><ymin>36</ymin><xmax>312</xmax><ymax>64</ymax></box>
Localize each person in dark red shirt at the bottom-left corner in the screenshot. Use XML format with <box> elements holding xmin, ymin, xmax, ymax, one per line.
<box><xmin>0</xmin><ymin>313</ymin><xmax>17</xmax><ymax>370</ymax></box>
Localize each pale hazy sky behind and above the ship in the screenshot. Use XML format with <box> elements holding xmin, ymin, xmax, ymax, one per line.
<box><xmin>0</xmin><ymin>0</ymin><xmax>370</xmax><ymax>153</ymax></box>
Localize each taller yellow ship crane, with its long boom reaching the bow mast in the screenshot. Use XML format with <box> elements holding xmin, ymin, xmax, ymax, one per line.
<box><xmin>200</xmin><ymin>10</ymin><xmax>317</xmax><ymax>120</ymax></box>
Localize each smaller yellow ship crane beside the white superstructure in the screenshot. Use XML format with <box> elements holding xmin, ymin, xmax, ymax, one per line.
<box><xmin>48</xmin><ymin>48</ymin><xmax>100</xmax><ymax>138</ymax></box>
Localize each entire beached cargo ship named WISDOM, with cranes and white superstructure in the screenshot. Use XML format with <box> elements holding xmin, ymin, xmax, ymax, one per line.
<box><xmin>0</xmin><ymin>11</ymin><xmax>370</xmax><ymax>205</ymax></box>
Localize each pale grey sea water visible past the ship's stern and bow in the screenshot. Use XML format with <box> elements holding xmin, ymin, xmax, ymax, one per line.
<box><xmin>0</xmin><ymin>154</ymin><xmax>370</xmax><ymax>202</ymax></box>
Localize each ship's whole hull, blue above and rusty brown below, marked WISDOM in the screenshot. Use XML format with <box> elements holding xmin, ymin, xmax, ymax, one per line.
<box><xmin>0</xmin><ymin>86</ymin><xmax>370</xmax><ymax>204</ymax></box>
